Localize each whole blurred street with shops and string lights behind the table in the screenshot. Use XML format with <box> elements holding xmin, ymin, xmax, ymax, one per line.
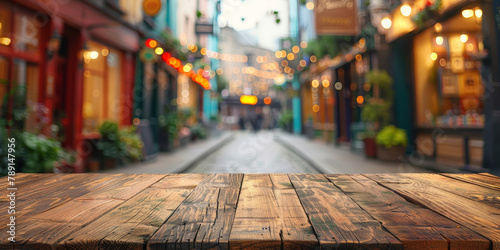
<box><xmin>0</xmin><ymin>0</ymin><xmax>500</xmax><ymax>175</ymax></box>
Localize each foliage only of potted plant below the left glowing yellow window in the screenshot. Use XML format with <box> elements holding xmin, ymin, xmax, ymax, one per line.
<box><xmin>97</xmin><ymin>121</ymin><xmax>127</xmax><ymax>159</ymax></box>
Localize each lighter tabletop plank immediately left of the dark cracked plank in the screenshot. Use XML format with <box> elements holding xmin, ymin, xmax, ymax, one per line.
<box><xmin>58</xmin><ymin>175</ymin><xmax>201</xmax><ymax>249</ymax></box>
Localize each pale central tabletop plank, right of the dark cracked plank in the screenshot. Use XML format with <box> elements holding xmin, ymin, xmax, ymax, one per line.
<box><xmin>229</xmin><ymin>174</ymin><xmax>318</xmax><ymax>249</ymax></box>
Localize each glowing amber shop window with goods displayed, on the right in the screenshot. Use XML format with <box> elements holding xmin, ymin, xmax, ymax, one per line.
<box><xmin>413</xmin><ymin>9</ymin><xmax>484</xmax><ymax>128</ymax></box>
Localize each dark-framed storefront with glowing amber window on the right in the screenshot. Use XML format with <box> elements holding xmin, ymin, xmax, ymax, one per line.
<box><xmin>387</xmin><ymin>0</ymin><xmax>498</xmax><ymax>170</ymax></box>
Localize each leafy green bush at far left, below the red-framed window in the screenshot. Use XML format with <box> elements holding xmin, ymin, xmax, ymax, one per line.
<box><xmin>16</xmin><ymin>132</ymin><xmax>64</xmax><ymax>173</ymax></box>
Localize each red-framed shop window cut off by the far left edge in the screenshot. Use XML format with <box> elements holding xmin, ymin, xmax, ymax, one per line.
<box><xmin>0</xmin><ymin>4</ymin><xmax>42</xmax><ymax>133</ymax></box>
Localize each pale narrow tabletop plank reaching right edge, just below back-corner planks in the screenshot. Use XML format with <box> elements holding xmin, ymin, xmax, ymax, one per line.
<box><xmin>401</xmin><ymin>174</ymin><xmax>500</xmax><ymax>209</ymax></box>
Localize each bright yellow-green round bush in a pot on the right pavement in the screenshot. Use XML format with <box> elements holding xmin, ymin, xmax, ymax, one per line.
<box><xmin>375</xmin><ymin>125</ymin><xmax>408</xmax><ymax>161</ymax></box>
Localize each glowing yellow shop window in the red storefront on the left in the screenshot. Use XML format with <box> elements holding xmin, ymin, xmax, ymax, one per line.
<box><xmin>82</xmin><ymin>42</ymin><xmax>122</xmax><ymax>133</ymax></box>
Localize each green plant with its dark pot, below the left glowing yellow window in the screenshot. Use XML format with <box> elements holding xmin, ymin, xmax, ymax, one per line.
<box><xmin>97</xmin><ymin>121</ymin><xmax>126</xmax><ymax>169</ymax></box>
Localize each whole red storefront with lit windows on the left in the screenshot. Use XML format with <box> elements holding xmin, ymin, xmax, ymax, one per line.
<box><xmin>0</xmin><ymin>0</ymin><xmax>138</xmax><ymax>172</ymax></box>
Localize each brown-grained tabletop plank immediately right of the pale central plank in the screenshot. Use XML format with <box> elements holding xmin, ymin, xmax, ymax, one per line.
<box><xmin>289</xmin><ymin>174</ymin><xmax>403</xmax><ymax>249</ymax></box>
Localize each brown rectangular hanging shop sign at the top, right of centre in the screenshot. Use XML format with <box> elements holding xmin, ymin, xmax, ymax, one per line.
<box><xmin>314</xmin><ymin>0</ymin><xmax>359</xmax><ymax>35</ymax></box>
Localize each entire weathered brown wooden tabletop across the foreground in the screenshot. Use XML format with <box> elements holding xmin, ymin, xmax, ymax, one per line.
<box><xmin>0</xmin><ymin>174</ymin><xmax>500</xmax><ymax>249</ymax></box>
